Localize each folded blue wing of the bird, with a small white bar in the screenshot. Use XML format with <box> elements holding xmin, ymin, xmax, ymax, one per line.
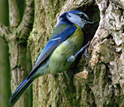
<box><xmin>27</xmin><ymin>25</ymin><xmax>77</xmax><ymax>78</ymax></box>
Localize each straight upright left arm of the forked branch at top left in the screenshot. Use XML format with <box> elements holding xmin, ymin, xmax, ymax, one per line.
<box><xmin>8</xmin><ymin>0</ymin><xmax>20</xmax><ymax>27</ymax></box>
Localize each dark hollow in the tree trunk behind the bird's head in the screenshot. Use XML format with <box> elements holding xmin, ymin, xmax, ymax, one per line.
<box><xmin>77</xmin><ymin>3</ymin><xmax>100</xmax><ymax>45</ymax></box>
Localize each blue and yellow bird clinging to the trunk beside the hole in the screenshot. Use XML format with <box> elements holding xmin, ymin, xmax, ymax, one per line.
<box><xmin>9</xmin><ymin>10</ymin><xmax>93</xmax><ymax>106</ymax></box>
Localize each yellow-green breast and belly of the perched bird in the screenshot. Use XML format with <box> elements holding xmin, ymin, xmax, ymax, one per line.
<box><xmin>49</xmin><ymin>25</ymin><xmax>84</xmax><ymax>74</ymax></box>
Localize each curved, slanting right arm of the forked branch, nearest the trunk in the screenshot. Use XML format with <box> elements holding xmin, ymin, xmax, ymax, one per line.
<box><xmin>17</xmin><ymin>0</ymin><xmax>34</xmax><ymax>40</ymax></box>
